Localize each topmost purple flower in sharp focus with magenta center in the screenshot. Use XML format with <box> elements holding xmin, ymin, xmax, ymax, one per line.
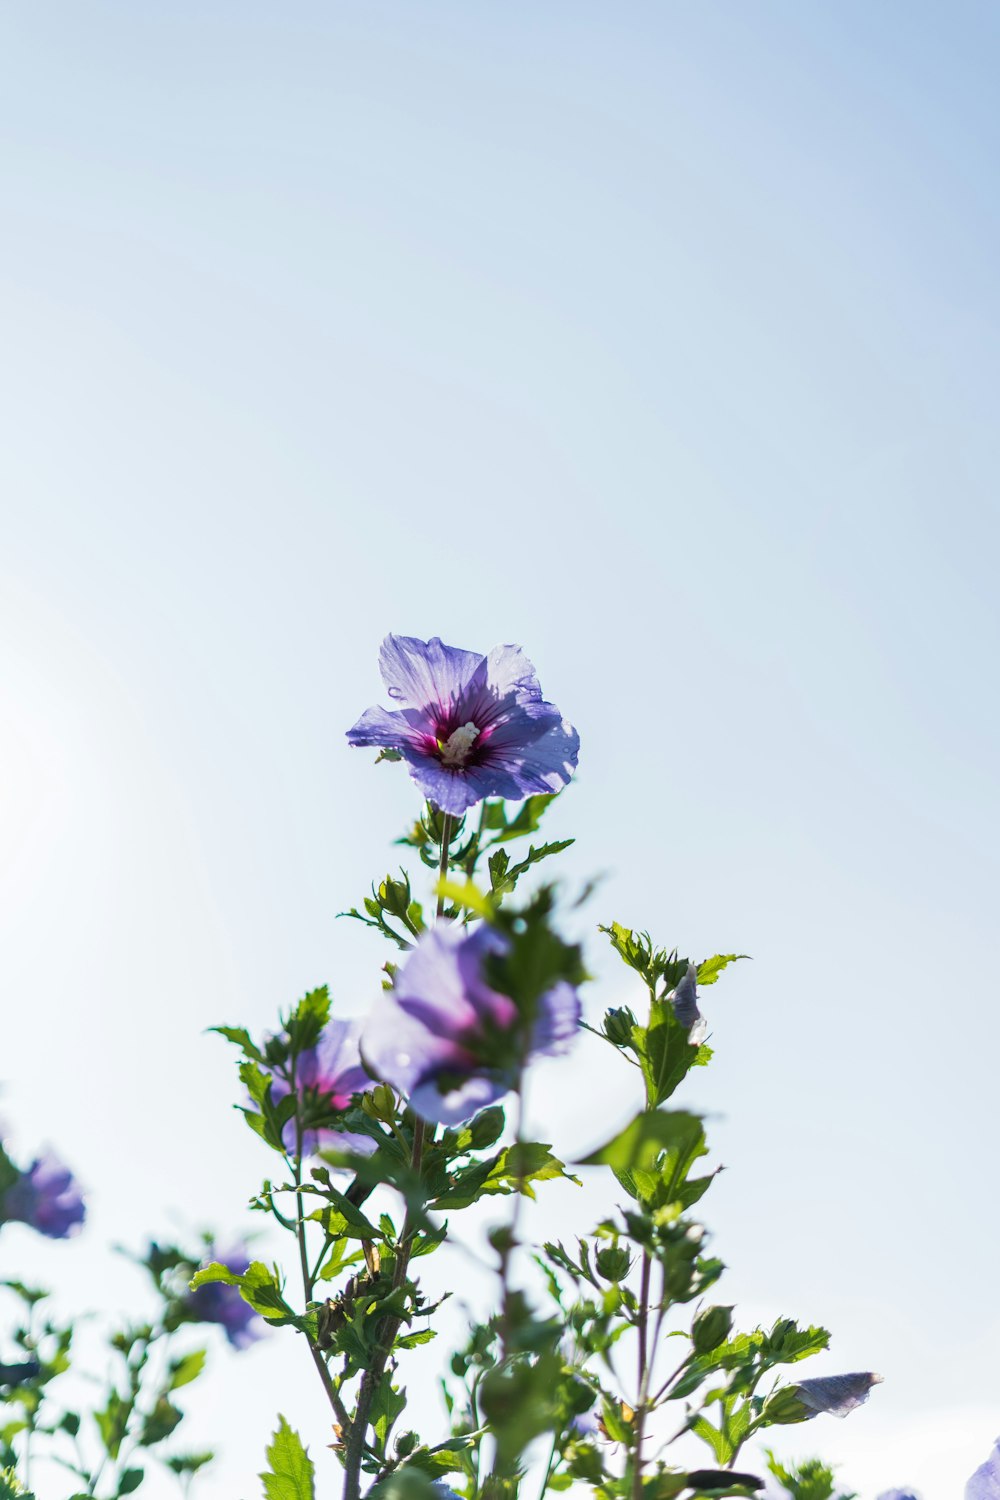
<box><xmin>348</xmin><ymin>636</ymin><xmax>580</xmax><ymax>816</ymax></box>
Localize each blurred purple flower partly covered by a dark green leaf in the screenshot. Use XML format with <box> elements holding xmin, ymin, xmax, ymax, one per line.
<box><xmin>361</xmin><ymin>923</ymin><xmax>580</xmax><ymax>1125</ymax></box>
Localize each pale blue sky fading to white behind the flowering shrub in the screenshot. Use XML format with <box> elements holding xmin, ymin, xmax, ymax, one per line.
<box><xmin>0</xmin><ymin>0</ymin><xmax>1000</xmax><ymax>1500</ymax></box>
